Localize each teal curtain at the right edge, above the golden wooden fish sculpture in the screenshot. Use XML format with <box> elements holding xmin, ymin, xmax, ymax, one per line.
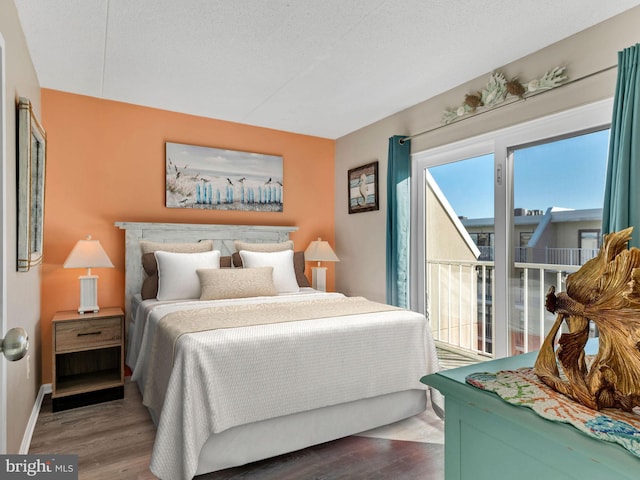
<box><xmin>602</xmin><ymin>44</ymin><xmax>640</xmax><ymax>247</ymax></box>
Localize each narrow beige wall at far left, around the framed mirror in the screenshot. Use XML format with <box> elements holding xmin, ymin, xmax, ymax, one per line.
<box><xmin>0</xmin><ymin>0</ymin><xmax>46</xmax><ymax>453</ymax></box>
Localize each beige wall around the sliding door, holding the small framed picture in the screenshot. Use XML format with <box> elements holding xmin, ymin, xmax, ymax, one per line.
<box><xmin>335</xmin><ymin>7</ymin><xmax>640</xmax><ymax>302</ymax></box>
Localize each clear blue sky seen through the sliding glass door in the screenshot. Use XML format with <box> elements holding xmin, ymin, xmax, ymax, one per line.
<box><xmin>429</xmin><ymin>130</ymin><xmax>609</xmax><ymax>218</ymax></box>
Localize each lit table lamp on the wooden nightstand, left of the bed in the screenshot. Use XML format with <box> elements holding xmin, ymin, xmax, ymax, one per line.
<box><xmin>64</xmin><ymin>235</ymin><xmax>113</xmax><ymax>313</ymax></box>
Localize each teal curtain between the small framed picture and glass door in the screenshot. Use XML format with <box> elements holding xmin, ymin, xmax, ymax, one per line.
<box><xmin>387</xmin><ymin>135</ymin><xmax>411</xmax><ymax>308</ymax></box>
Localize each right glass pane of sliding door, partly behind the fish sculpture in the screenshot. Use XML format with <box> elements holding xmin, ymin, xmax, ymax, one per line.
<box><xmin>509</xmin><ymin>130</ymin><xmax>609</xmax><ymax>354</ymax></box>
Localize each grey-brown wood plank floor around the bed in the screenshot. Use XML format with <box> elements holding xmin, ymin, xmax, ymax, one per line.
<box><xmin>29</xmin><ymin>346</ymin><xmax>476</xmax><ymax>480</ymax></box>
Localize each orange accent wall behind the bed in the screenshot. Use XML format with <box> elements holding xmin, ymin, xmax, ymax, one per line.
<box><xmin>41</xmin><ymin>89</ymin><xmax>335</xmax><ymax>383</ymax></box>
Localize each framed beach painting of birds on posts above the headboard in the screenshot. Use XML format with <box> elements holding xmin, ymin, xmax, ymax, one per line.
<box><xmin>165</xmin><ymin>142</ymin><xmax>284</xmax><ymax>212</ymax></box>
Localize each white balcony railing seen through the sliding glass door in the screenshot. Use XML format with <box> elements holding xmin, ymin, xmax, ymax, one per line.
<box><xmin>425</xmin><ymin>260</ymin><xmax>579</xmax><ymax>356</ymax></box>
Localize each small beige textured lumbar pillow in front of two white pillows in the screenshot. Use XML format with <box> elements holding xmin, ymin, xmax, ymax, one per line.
<box><xmin>197</xmin><ymin>267</ymin><xmax>278</xmax><ymax>300</ymax></box>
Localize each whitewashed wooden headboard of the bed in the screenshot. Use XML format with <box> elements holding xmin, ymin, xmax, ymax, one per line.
<box><xmin>115</xmin><ymin>222</ymin><xmax>298</xmax><ymax>316</ymax></box>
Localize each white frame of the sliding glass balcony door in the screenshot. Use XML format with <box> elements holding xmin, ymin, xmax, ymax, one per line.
<box><xmin>409</xmin><ymin>98</ymin><xmax>613</xmax><ymax>358</ymax></box>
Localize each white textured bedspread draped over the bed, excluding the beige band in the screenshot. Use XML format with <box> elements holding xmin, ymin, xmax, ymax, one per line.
<box><xmin>133</xmin><ymin>293</ymin><xmax>441</xmax><ymax>479</ymax></box>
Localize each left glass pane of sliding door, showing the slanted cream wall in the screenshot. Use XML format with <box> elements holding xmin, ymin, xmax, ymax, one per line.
<box><xmin>425</xmin><ymin>154</ymin><xmax>495</xmax><ymax>353</ymax></box>
